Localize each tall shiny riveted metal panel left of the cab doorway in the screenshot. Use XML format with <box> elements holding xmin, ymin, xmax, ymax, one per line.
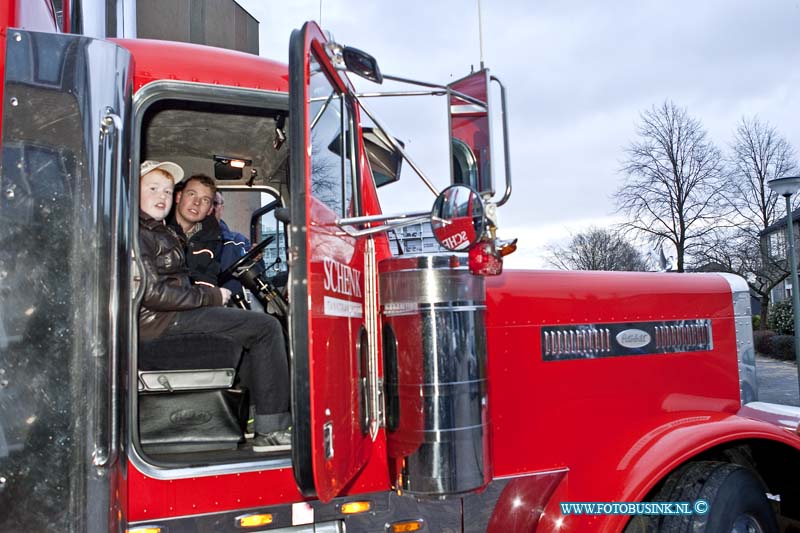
<box><xmin>0</xmin><ymin>31</ymin><xmax>133</xmax><ymax>531</ymax></box>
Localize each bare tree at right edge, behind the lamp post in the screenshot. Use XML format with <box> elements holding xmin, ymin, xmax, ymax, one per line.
<box><xmin>695</xmin><ymin>117</ymin><xmax>797</xmax><ymax>324</ymax></box>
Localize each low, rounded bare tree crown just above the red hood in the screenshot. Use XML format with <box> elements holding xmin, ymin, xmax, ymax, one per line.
<box><xmin>546</xmin><ymin>227</ymin><xmax>646</xmax><ymax>271</ymax></box>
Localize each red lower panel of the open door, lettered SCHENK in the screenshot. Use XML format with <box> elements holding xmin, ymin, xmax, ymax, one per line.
<box><xmin>308</xmin><ymin>195</ymin><xmax>371</xmax><ymax>501</ymax></box>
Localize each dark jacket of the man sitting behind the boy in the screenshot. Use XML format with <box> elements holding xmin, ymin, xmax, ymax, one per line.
<box><xmin>168</xmin><ymin>213</ymin><xmax>222</xmax><ymax>287</ymax></box>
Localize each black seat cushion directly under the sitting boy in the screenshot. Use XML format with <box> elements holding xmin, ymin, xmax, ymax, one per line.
<box><xmin>139</xmin><ymin>333</ymin><xmax>242</xmax><ymax>370</ymax></box>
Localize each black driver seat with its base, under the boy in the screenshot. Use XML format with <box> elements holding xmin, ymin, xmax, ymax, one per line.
<box><xmin>138</xmin><ymin>334</ymin><xmax>248</xmax><ymax>454</ymax></box>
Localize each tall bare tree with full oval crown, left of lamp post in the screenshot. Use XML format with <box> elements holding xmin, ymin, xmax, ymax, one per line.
<box><xmin>614</xmin><ymin>101</ymin><xmax>723</xmax><ymax>272</ymax></box>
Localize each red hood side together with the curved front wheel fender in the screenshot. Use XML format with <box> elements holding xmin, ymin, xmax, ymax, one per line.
<box><xmin>487</xmin><ymin>271</ymin><xmax>800</xmax><ymax>531</ymax></box>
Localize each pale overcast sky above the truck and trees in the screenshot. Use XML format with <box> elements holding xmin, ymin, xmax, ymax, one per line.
<box><xmin>237</xmin><ymin>0</ymin><xmax>800</xmax><ymax>268</ymax></box>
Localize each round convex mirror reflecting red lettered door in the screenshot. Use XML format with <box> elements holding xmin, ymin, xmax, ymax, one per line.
<box><xmin>431</xmin><ymin>185</ymin><xmax>486</xmax><ymax>251</ymax></box>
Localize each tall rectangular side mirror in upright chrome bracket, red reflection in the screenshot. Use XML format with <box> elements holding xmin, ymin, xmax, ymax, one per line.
<box><xmin>447</xmin><ymin>69</ymin><xmax>494</xmax><ymax>195</ymax></box>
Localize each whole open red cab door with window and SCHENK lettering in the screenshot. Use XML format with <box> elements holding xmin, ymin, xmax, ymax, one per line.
<box><xmin>289</xmin><ymin>22</ymin><xmax>377</xmax><ymax>501</ymax></box>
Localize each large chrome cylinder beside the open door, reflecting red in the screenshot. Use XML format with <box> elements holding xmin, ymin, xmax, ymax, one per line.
<box><xmin>379</xmin><ymin>254</ymin><xmax>491</xmax><ymax>496</ymax></box>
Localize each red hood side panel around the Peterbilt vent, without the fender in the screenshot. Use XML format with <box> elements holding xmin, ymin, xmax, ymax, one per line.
<box><xmin>487</xmin><ymin>271</ymin><xmax>739</xmax><ymax>475</ymax></box>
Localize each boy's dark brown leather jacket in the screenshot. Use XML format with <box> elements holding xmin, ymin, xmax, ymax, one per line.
<box><xmin>139</xmin><ymin>211</ymin><xmax>222</xmax><ymax>340</ymax></box>
